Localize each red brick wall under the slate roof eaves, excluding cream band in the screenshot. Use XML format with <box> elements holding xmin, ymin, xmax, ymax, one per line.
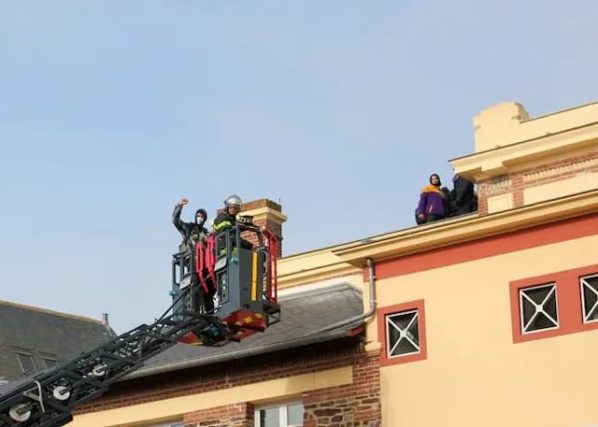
<box><xmin>74</xmin><ymin>337</ymin><xmax>380</xmax><ymax>427</ymax></box>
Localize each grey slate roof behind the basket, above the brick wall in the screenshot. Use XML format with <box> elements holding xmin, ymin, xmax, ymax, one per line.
<box><xmin>123</xmin><ymin>283</ymin><xmax>364</xmax><ymax>380</ymax></box>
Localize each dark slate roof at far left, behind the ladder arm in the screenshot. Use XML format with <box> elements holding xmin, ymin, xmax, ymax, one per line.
<box><xmin>0</xmin><ymin>301</ymin><xmax>114</xmax><ymax>384</ymax></box>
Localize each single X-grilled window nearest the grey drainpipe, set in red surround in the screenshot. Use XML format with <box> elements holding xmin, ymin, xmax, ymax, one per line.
<box><xmin>386</xmin><ymin>310</ymin><xmax>420</xmax><ymax>358</ymax></box>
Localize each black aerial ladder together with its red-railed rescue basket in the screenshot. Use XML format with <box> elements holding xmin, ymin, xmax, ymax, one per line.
<box><xmin>0</xmin><ymin>221</ymin><xmax>280</xmax><ymax>427</ymax></box>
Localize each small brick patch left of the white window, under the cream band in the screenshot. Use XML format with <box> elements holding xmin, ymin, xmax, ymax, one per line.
<box><xmin>183</xmin><ymin>403</ymin><xmax>255</xmax><ymax>427</ymax></box>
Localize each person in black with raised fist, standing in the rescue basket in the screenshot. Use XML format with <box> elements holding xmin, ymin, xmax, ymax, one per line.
<box><xmin>172</xmin><ymin>198</ymin><xmax>216</xmax><ymax>313</ymax></box>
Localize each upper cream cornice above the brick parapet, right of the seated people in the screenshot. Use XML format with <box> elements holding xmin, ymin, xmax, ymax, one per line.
<box><xmin>450</xmin><ymin>122</ymin><xmax>598</xmax><ymax>182</ymax></box>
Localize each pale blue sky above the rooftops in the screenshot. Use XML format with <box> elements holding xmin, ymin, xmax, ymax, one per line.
<box><xmin>0</xmin><ymin>0</ymin><xmax>598</xmax><ymax>332</ymax></box>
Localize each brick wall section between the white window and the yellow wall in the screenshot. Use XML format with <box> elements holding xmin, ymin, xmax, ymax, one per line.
<box><xmin>302</xmin><ymin>354</ymin><xmax>382</xmax><ymax>427</ymax></box>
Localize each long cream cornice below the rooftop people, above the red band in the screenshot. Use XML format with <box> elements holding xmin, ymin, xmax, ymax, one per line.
<box><xmin>334</xmin><ymin>190</ymin><xmax>598</xmax><ymax>266</ymax></box>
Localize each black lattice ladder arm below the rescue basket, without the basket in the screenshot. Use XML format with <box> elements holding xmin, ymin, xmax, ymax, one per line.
<box><xmin>0</xmin><ymin>312</ymin><xmax>230</xmax><ymax>427</ymax></box>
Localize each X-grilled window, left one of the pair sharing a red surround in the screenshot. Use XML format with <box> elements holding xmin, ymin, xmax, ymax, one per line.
<box><xmin>519</xmin><ymin>283</ymin><xmax>559</xmax><ymax>334</ymax></box>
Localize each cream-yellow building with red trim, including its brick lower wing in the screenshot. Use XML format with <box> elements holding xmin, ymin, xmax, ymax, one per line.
<box><xmin>72</xmin><ymin>103</ymin><xmax>598</xmax><ymax>427</ymax></box>
